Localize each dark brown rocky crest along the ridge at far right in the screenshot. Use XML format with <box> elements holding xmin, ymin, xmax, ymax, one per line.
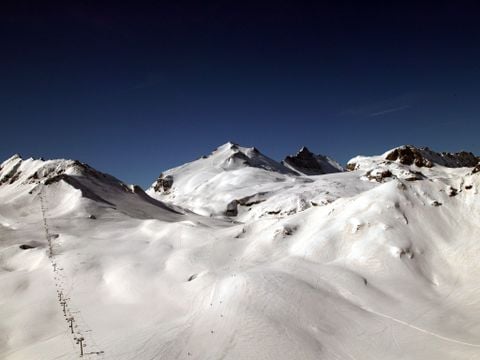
<box><xmin>385</xmin><ymin>145</ymin><xmax>478</xmax><ymax>168</ymax></box>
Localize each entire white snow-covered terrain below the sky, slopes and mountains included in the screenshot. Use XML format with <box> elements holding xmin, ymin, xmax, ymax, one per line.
<box><xmin>0</xmin><ymin>143</ymin><xmax>480</xmax><ymax>360</ymax></box>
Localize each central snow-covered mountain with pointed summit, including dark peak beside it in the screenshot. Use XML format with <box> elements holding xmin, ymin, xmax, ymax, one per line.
<box><xmin>147</xmin><ymin>143</ymin><xmax>356</xmax><ymax>220</ymax></box>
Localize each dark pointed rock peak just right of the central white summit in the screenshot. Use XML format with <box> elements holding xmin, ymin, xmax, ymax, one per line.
<box><xmin>283</xmin><ymin>147</ymin><xmax>342</xmax><ymax>175</ymax></box>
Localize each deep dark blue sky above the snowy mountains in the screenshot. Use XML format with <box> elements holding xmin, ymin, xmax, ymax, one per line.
<box><xmin>0</xmin><ymin>0</ymin><xmax>480</xmax><ymax>186</ymax></box>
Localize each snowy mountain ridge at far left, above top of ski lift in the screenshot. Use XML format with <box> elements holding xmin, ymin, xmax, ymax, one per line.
<box><xmin>0</xmin><ymin>155</ymin><xmax>181</xmax><ymax>218</ymax></box>
